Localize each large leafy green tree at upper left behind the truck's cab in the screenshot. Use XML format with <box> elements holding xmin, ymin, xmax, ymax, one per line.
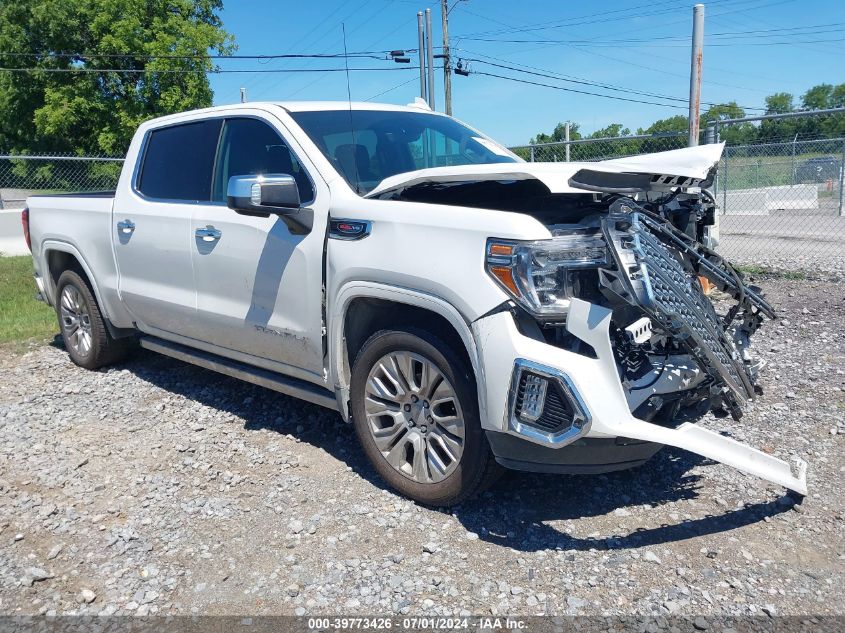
<box><xmin>0</xmin><ymin>0</ymin><xmax>234</xmax><ymax>154</ymax></box>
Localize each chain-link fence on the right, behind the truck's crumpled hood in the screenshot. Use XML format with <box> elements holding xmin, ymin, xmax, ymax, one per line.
<box><xmin>511</xmin><ymin>108</ymin><xmax>845</xmax><ymax>274</ymax></box>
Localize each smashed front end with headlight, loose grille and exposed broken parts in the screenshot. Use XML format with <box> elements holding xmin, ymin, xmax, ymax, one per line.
<box><xmin>487</xmin><ymin>192</ymin><xmax>774</xmax><ymax>427</ymax></box>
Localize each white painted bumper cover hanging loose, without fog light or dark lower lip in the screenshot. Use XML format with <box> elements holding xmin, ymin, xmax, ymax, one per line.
<box><xmin>473</xmin><ymin>299</ymin><xmax>807</xmax><ymax>495</ymax></box>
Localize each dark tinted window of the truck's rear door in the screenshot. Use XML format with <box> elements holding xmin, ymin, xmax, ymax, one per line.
<box><xmin>137</xmin><ymin>119</ymin><xmax>223</xmax><ymax>202</ymax></box>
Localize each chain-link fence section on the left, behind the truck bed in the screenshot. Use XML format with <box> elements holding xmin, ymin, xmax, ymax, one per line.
<box><xmin>0</xmin><ymin>154</ymin><xmax>123</xmax><ymax>209</ymax></box>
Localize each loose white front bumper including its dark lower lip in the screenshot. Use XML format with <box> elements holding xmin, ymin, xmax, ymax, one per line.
<box><xmin>473</xmin><ymin>299</ymin><xmax>807</xmax><ymax>495</ymax></box>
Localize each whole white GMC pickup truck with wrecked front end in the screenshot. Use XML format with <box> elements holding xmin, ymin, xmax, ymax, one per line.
<box><xmin>24</xmin><ymin>103</ymin><xmax>806</xmax><ymax>505</ymax></box>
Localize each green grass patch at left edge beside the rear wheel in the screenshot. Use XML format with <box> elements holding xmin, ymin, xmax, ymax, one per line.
<box><xmin>0</xmin><ymin>256</ymin><xmax>58</xmax><ymax>350</ymax></box>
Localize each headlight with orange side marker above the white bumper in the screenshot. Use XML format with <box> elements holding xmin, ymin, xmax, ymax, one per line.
<box><xmin>487</xmin><ymin>230</ymin><xmax>607</xmax><ymax>317</ymax></box>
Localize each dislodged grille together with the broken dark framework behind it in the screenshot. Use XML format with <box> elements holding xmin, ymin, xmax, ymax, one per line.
<box><xmin>601</xmin><ymin>199</ymin><xmax>774</xmax><ymax>419</ymax></box>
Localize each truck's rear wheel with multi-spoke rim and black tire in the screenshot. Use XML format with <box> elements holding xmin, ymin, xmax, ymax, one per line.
<box><xmin>56</xmin><ymin>270</ymin><xmax>130</xmax><ymax>369</ymax></box>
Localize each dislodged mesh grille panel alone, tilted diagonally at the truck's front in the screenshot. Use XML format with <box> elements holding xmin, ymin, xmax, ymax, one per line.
<box><xmin>605</xmin><ymin>212</ymin><xmax>754</xmax><ymax>401</ymax></box>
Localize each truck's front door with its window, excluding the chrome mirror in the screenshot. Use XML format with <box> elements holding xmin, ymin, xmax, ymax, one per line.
<box><xmin>191</xmin><ymin>118</ymin><xmax>328</xmax><ymax>378</ymax></box>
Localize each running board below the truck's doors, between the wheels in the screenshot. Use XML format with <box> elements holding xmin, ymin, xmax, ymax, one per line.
<box><xmin>140</xmin><ymin>336</ymin><xmax>338</xmax><ymax>411</ymax></box>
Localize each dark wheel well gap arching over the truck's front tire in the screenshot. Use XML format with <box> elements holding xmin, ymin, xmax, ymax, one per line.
<box><xmin>343</xmin><ymin>297</ymin><xmax>474</xmax><ymax>376</ymax></box>
